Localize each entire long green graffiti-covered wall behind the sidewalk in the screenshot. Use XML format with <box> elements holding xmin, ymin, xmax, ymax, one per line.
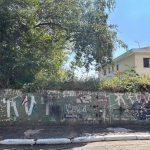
<box><xmin>0</xmin><ymin>90</ymin><xmax>150</xmax><ymax>126</ymax></box>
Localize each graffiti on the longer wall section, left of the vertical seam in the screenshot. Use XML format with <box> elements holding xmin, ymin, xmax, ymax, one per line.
<box><xmin>0</xmin><ymin>90</ymin><xmax>108</xmax><ymax>124</ymax></box>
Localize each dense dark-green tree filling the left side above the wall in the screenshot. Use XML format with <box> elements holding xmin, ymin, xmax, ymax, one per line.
<box><xmin>0</xmin><ymin>0</ymin><xmax>67</xmax><ymax>88</ymax></box>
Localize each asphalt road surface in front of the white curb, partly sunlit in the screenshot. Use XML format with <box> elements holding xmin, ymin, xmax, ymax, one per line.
<box><xmin>0</xmin><ymin>140</ymin><xmax>150</xmax><ymax>150</ymax></box>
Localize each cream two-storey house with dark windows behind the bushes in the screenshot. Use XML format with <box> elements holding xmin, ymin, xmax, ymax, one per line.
<box><xmin>100</xmin><ymin>46</ymin><xmax>150</xmax><ymax>78</ymax></box>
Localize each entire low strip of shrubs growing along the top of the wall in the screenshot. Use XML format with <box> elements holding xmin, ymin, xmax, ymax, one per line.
<box><xmin>24</xmin><ymin>66</ymin><xmax>150</xmax><ymax>93</ymax></box>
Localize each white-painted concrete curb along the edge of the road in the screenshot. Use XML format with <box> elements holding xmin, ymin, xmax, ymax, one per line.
<box><xmin>0</xmin><ymin>134</ymin><xmax>150</xmax><ymax>145</ymax></box>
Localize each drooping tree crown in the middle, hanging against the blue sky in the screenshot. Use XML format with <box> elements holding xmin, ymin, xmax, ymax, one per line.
<box><xmin>35</xmin><ymin>0</ymin><xmax>127</xmax><ymax>70</ymax></box>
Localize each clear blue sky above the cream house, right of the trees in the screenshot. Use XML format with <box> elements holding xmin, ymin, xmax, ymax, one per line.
<box><xmin>108</xmin><ymin>0</ymin><xmax>150</xmax><ymax>57</ymax></box>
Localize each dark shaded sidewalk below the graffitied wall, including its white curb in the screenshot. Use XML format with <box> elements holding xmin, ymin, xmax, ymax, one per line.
<box><xmin>0</xmin><ymin>125</ymin><xmax>150</xmax><ymax>144</ymax></box>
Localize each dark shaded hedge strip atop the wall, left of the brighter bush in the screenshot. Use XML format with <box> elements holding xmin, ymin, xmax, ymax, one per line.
<box><xmin>23</xmin><ymin>74</ymin><xmax>99</xmax><ymax>92</ymax></box>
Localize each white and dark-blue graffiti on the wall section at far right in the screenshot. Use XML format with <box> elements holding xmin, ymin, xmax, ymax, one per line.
<box><xmin>110</xmin><ymin>93</ymin><xmax>150</xmax><ymax>122</ymax></box>
